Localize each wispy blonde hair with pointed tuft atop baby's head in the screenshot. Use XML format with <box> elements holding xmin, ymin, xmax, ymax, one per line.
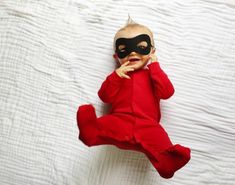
<box><xmin>113</xmin><ymin>14</ymin><xmax>155</xmax><ymax>49</ymax></box>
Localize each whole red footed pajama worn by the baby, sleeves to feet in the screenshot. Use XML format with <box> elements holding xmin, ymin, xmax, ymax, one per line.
<box><xmin>77</xmin><ymin>62</ymin><xmax>190</xmax><ymax>178</ymax></box>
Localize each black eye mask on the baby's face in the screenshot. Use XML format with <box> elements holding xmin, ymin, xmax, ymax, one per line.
<box><xmin>116</xmin><ymin>34</ymin><xmax>152</xmax><ymax>58</ymax></box>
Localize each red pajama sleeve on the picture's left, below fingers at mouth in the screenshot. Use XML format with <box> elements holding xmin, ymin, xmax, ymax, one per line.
<box><xmin>98</xmin><ymin>71</ymin><xmax>123</xmax><ymax>103</ymax></box>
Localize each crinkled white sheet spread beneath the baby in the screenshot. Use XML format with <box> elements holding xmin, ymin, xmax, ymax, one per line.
<box><xmin>0</xmin><ymin>0</ymin><xmax>235</xmax><ymax>185</ymax></box>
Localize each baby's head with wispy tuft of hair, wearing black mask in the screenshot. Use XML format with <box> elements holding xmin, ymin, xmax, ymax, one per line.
<box><xmin>114</xmin><ymin>18</ymin><xmax>155</xmax><ymax>69</ymax></box>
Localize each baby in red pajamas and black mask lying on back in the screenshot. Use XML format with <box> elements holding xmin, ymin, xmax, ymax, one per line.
<box><xmin>77</xmin><ymin>18</ymin><xmax>190</xmax><ymax>178</ymax></box>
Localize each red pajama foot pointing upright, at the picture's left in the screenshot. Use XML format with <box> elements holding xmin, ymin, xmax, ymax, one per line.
<box><xmin>77</xmin><ymin>105</ymin><xmax>98</xmax><ymax>146</ymax></box>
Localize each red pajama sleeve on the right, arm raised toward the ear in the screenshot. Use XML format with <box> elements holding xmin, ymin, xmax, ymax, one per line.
<box><xmin>148</xmin><ymin>62</ymin><xmax>175</xmax><ymax>99</ymax></box>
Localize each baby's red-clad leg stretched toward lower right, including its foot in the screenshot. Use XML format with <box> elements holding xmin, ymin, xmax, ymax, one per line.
<box><xmin>137</xmin><ymin>124</ymin><xmax>190</xmax><ymax>178</ymax></box>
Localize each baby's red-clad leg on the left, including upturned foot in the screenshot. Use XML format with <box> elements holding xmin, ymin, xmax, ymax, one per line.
<box><xmin>77</xmin><ymin>105</ymin><xmax>135</xmax><ymax>149</ymax></box>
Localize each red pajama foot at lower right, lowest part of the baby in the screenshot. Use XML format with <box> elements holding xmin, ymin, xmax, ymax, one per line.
<box><xmin>150</xmin><ymin>145</ymin><xmax>190</xmax><ymax>178</ymax></box>
